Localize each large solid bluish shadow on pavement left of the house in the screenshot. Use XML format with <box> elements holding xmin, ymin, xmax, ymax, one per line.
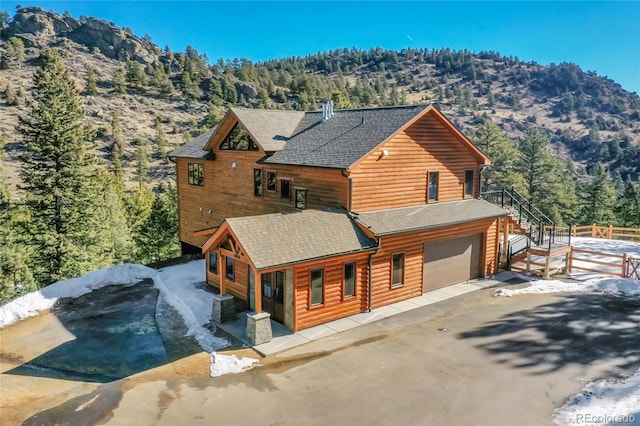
<box><xmin>4</xmin><ymin>280</ymin><xmax>202</xmax><ymax>383</ymax></box>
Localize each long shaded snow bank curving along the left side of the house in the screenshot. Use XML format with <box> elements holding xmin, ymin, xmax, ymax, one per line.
<box><xmin>0</xmin><ymin>260</ymin><xmax>258</xmax><ymax>377</ymax></box>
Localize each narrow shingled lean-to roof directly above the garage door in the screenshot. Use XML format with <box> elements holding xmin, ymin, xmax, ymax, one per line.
<box><xmin>356</xmin><ymin>199</ymin><xmax>507</xmax><ymax>237</ymax></box>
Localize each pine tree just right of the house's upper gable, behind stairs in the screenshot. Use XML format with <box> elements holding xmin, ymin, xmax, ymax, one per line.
<box><xmin>474</xmin><ymin>119</ymin><xmax>525</xmax><ymax>192</ymax></box>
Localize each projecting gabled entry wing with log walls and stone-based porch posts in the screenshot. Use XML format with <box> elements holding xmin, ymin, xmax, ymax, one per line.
<box><xmin>202</xmin><ymin>209</ymin><xmax>377</xmax><ymax>345</ymax></box>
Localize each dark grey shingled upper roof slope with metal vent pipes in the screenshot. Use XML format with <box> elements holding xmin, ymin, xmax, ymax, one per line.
<box><xmin>264</xmin><ymin>105</ymin><xmax>428</xmax><ymax>169</ymax></box>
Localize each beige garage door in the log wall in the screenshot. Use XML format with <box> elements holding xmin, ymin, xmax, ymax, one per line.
<box><xmin>422</xmin><ymin>234</ymin><xmax>482</xmax><ymax>292</ymax></box>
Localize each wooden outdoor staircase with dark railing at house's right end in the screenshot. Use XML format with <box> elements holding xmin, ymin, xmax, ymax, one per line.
<box><xmin>481</xmin><ymin>188</ymin><xmax>571</xmax><ymax>278</ymax></box>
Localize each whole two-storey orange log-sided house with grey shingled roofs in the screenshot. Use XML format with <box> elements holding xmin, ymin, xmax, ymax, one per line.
<box><xmin>171</xmin><ymin>103</ymin><xmax>506</xmax><ymax>340</ymax></box>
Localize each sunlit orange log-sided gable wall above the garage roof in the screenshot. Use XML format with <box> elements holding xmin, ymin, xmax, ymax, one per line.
<box><xmin>350</xmin><ymin>114</ymin><xmax>483</xmax><ymax>212</ymax></box>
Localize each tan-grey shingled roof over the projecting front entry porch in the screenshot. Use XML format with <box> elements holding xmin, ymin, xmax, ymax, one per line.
<box><xmin>221</xmin><ymin>209</ymin><xmax>376</xmax><ymax>270</ymax></box>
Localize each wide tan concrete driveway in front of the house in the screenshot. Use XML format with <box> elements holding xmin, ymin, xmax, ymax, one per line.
<box><xmin>0</xmin><ymin>282</ymin><xmax>640</xmax><ymax>425</ymax></box>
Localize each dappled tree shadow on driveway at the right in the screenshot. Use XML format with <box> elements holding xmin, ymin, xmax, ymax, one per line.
<box><xmin>458</xmin><ymin>293</ymin><xmax>640</xmax><ymax>374</ymax></box>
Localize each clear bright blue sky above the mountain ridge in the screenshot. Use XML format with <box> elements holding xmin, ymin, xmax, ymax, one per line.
<box><xmin>5</xmin><ymin>0</ymin><xmax>640</xmax><ymax>94</ymax></box>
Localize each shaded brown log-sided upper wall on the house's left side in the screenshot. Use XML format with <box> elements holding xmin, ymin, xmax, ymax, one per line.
<box><xmin>176</xmin><ymin>156</ymin><xmax>349</xmax><ymax>247</ymax></box>
